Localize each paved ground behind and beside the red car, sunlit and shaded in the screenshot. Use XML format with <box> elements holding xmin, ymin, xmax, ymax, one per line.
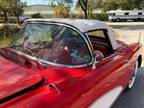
<box><xmin>109</xmin><ymin>22</ymin><xmax>144</xmax><ymax>108</ymax></box>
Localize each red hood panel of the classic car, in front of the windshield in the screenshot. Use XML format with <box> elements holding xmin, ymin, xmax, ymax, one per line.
<box><xmin>0</xmin><ymin>51</ymin><xmax>43</xmax><ymax>103</ymax></box>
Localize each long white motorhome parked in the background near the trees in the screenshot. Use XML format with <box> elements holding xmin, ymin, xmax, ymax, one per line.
<box><xmin>109</xmin><ymin>10</ymin><xmax>144</xmax><ymax>22</ymax></box>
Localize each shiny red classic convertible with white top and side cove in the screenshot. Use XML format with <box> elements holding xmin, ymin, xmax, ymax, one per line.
<box><xmin>0</xmin><ymin>19</ymin><xmax>142</xmax><ymax>108</ymax></box>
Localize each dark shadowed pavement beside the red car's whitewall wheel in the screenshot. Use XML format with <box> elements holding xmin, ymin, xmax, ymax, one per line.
<box><xmin>112</xmin><ymin>67</ymin><xmax>144</xmax><ymax>108</ymax></box>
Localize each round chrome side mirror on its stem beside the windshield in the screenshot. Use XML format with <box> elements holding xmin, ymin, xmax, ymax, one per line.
<box><xmin>92</xmin><ymin>50</ymin><xmax>104</xmax><ymax>69</ymax></box>
